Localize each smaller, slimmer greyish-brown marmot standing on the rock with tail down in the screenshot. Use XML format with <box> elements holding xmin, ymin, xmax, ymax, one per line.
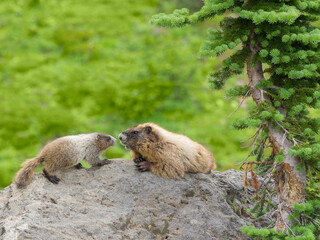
<box><xmin>15</xmin><ymin>133</ymin><xmax>117</xmax><ymax>187</ymax></box>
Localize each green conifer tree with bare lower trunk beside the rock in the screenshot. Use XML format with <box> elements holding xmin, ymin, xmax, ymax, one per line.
<box><xmin>151</xmin><ymin>0</ymin><xmax>320</xmax><ymax>230</ymax></box>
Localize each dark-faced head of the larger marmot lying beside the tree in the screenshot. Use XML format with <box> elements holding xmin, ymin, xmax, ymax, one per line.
<box><xmin>119</xmin><ymin>123</ymin><xmax>159</xmax><ymax>150</ymax></box>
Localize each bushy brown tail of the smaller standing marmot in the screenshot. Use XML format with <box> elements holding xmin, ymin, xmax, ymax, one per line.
<box><xmin>15</xmin><ymin>157</ymin><xmax>42</xmax><ymax>187</ymax></box>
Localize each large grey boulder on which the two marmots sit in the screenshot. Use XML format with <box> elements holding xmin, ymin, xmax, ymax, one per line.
<box><xmin>0</xmin><ymin>159</ymin><xmax>272</xmax><ymax>240</ymax></box>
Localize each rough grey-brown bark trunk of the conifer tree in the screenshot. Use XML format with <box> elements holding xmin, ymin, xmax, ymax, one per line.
<box><xmin>247</xmin><ymin>28</ymin><xmax>306</xmax><ymax>231</ymax></box>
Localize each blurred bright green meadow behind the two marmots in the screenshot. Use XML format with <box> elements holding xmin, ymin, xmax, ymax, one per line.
<box><xmin>0</xmin><ymin>0</ymin><xmax>255</xmax><ymax>188</ymax></box>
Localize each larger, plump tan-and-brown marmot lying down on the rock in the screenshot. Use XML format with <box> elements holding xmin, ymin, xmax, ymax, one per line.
<box><xmin>119</xmin><ymin>123</ymin><xmax>216</xmax><ymax>179</ymax></box>
